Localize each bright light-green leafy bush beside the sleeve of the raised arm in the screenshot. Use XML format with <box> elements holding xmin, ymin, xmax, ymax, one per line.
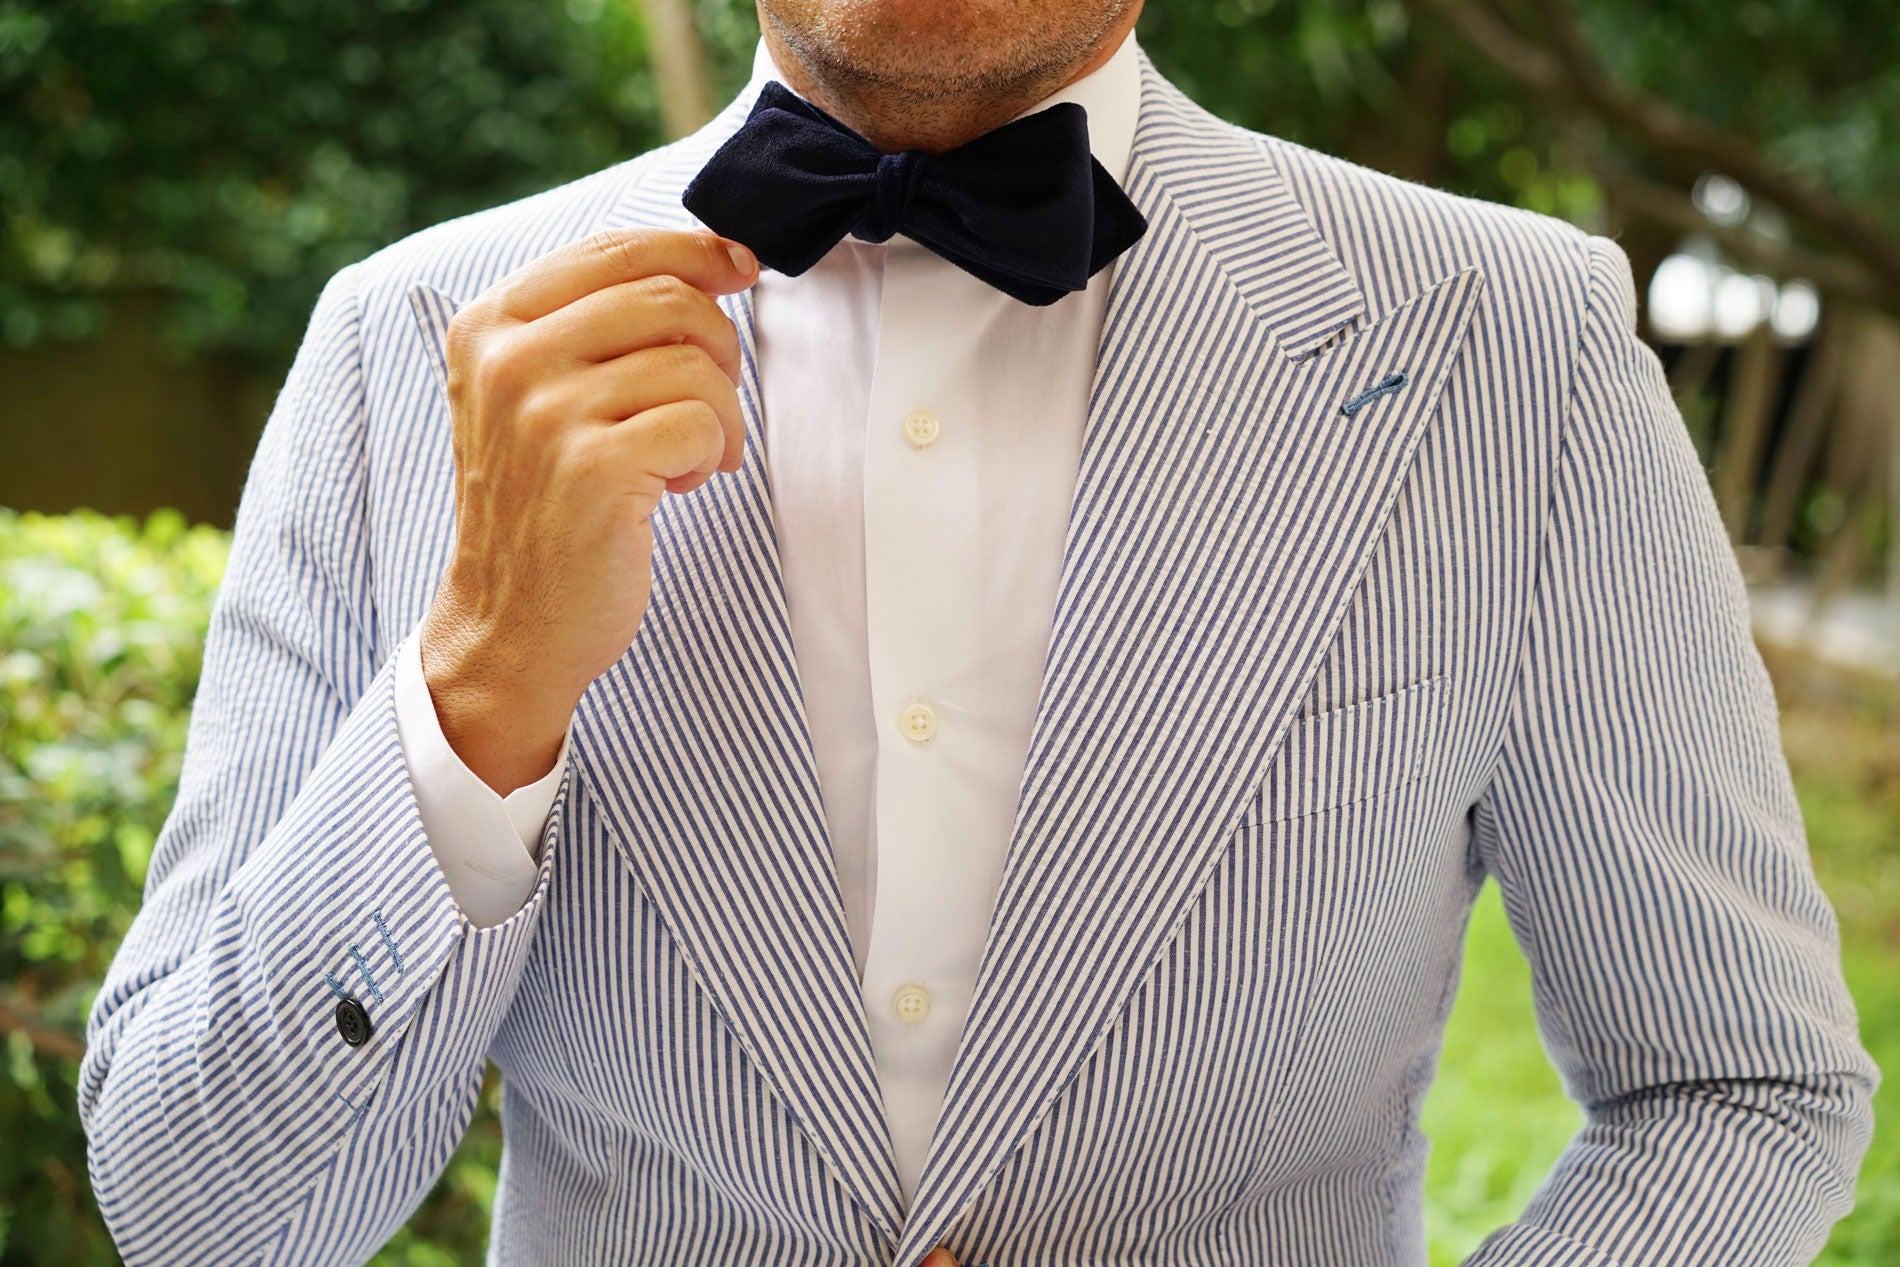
<box><xmin>0</xmin><ymin>507</ymin><xmax>502</xmax><ymax>1267</ymax></box>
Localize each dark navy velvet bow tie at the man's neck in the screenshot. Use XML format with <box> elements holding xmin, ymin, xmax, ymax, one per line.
<box><xmin>680</xmin><ymin>84</ymin><xmax>1148</xmax><ymax>306</ymax></box>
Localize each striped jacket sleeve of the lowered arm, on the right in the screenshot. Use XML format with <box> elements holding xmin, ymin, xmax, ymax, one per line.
<box><xmin>1467</xmin><ymin>237</ymin><xmax>1879</xmax><ymax>1267</ymax></box>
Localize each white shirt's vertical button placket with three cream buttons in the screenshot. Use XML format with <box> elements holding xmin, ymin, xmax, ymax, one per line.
<box><xmin>863</xmin><ymin>239</ymin><xmax>990</xmax><ymax>1200</ymax></box>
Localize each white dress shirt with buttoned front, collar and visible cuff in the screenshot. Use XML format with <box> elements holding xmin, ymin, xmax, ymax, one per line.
<box><xmin>397</xmin><ymin>34</ymin><xmax>1140</xmax><ymax>1202</ymax></box>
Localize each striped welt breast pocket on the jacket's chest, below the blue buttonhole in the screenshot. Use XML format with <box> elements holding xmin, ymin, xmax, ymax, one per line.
<box><xmin>1243</xmin><ymin>672</ymin><xmax>1452</xmax><ymax>823</ymax></box>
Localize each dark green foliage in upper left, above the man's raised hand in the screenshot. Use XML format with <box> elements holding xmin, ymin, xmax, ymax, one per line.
<box><xmin>0</xmin><ymin>0</ymin><xmax>659</xmax><ymax>361</ymax></box>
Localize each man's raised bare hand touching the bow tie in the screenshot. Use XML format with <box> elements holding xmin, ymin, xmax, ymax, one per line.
<box><xmin>420</xmin><ymin>230</ymin><xmax>758</xmax><ymax>794</ymax></box>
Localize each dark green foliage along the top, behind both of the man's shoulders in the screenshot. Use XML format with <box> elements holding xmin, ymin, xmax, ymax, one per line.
<box><xmin>0</xmin><ymin>0</ymin><xmax>1900</xmax><ymax>370</ymax></box>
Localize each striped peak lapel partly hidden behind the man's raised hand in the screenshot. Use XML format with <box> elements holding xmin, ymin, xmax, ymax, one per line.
<box><xmin>400</xmin><ymin>103</ymin><xmax>903</xmax><ymax>1242</ymax></box>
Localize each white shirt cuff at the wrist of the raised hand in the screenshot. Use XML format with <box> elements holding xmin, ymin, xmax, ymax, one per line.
<box><xmin>395</xmin><ymin>627</ymin><xmax>574</xmax><ymax>929</ymax></box>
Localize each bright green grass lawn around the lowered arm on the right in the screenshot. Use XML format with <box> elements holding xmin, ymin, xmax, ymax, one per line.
<box><xmin>1425</xmin><ymin>695</ymin><xmax>1900</xmax><ymax>1267</ymax></box>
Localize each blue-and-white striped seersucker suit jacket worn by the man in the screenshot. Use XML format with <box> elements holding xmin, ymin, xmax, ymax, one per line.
<box><xmin>82</xmin><ymin>44</ymin><xmax>1877</xmax><ymax>1267</ymax></box>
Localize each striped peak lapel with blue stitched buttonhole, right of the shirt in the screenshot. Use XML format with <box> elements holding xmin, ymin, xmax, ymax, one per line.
<box><xmin>897</xmin><ymin>57</ymin><xmax>1482</xmax><ymax>1263</ymax></box>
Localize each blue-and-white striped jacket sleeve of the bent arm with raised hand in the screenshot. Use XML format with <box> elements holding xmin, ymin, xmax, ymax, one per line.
<box><xmin>80</xmin><ymin>266</ymin><xmax>566</xmax><ymax>1267</ymax></box>
